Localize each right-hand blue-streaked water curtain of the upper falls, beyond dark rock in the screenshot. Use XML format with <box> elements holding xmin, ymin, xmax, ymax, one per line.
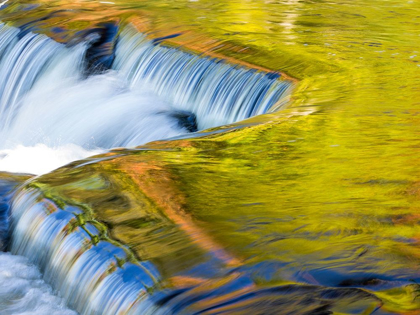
<box><xmin>113</xmin><ymin>27</ymin><xmax>291</xmax><ymax>129</ymax></box>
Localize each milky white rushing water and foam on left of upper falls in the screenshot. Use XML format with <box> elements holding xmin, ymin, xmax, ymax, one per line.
<box><xmin>0</xmin><ymin>24</ymin><xmax>187</xmax><ymax>174</ymax></box>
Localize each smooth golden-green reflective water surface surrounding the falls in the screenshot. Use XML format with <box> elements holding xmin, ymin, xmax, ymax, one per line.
<box><xmin>0</xmin><ymin>0</ymin><xmax>420</xmax><ymax>314</ymax></box>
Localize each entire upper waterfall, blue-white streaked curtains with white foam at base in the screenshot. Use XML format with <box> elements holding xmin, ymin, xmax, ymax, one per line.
<box><xmin>0</xmin><ymin>24</ymin><xmax>291</xmax><ymax>173</ymax></box>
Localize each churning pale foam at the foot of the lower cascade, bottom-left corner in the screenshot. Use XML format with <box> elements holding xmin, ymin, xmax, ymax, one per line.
<box><xmin>0</xmin><ymin>253</ymin><xmax>77</xmax><ymax>315</ymax></box>
